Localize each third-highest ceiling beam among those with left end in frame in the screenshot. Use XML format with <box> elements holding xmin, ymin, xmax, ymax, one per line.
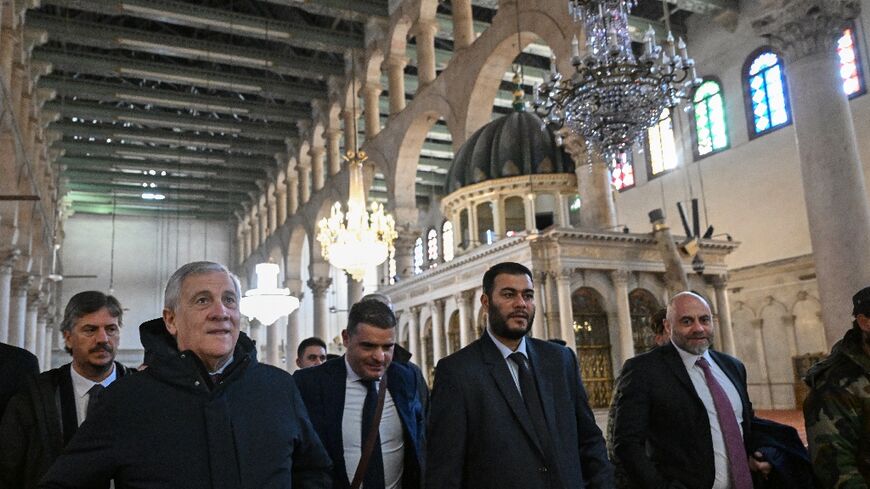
<box><xmin>38</xmin><ymin>76</ymin><xmax>311</xmax><ymax>122</ymax></box>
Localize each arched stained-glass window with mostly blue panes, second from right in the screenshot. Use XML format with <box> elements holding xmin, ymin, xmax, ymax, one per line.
<box><xmin>743</xmin><ymin>49</ymin><xmax>791</xmax><ymax>137</ymax></box>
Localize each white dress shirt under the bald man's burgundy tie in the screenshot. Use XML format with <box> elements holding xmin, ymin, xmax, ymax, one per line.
<box><xmin>674</xmin><ymin>345</ymin><xmax>743</xmax><ymax>489</ymax></box>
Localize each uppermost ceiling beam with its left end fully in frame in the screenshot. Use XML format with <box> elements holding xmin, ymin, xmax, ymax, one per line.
<box><xmin>27</xmin><ymin>12</ymin><xmax>344</xmax><ymax>81</ymax></box>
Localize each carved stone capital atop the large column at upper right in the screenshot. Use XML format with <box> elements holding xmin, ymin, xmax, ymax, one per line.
<box><xmin>752</xmin><ymin>0</ymin><xmax>861</xmax><ymax>62</ymax></box>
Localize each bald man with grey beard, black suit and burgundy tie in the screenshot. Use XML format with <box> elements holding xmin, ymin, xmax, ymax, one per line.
<box><xmin>614</xmin><ymin>292</ymin><xmax>771</xmax><ymax>489</ymax></box>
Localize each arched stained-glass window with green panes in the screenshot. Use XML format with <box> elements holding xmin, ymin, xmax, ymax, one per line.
<box><xmin>692</xmin><ymin>80</ymin><xmax>728</xmax><ymax>157</ymax></box>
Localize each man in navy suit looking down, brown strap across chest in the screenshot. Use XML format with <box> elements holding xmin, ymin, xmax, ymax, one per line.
<box><xmin>293</xmin><ymin>300</ymin><xmax>425</xmax><ymax>489</ymax></box>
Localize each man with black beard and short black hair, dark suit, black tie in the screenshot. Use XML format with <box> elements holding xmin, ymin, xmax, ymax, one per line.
<box><xmin>426</xmin><ymin>262</ymin><xmax>613</xmax><ymax>489</ymax></box>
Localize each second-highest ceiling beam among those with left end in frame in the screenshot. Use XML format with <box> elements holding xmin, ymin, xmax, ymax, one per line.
<box><xmin>33</xmin><ymin>47</ymin><xmax>326</xmax><ymax>103</ymax></box>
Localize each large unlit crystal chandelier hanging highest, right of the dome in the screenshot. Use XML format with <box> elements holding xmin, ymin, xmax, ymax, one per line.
<box><xmin>534</xmin><ymin>0</ymin><xmax>701</xmax><ymax>162</ymax></box>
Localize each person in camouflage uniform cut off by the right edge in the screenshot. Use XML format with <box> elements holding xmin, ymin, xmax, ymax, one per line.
<box><xmin>804</xmin><ymin>287</ymin><xmax>870</xmax><ymax>489</ymax></box>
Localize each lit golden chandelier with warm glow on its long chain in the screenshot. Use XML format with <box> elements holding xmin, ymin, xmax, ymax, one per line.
<box><xmin>317</xmin><ymin>63</ymin><xmax>398</xmax><ymax>281</ymax></box>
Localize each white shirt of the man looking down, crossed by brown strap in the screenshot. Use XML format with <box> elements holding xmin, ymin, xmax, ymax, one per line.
<box><xmin>341</xmin><ymin>358</ymin><xmax>405</xmax><ymax>489</ymax></box>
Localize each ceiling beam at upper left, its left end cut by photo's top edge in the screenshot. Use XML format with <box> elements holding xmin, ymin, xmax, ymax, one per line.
<box><xmin>42</xmin><ymin>0</ymin><xmax>363</xmax><ymax>54</ymax></box>
